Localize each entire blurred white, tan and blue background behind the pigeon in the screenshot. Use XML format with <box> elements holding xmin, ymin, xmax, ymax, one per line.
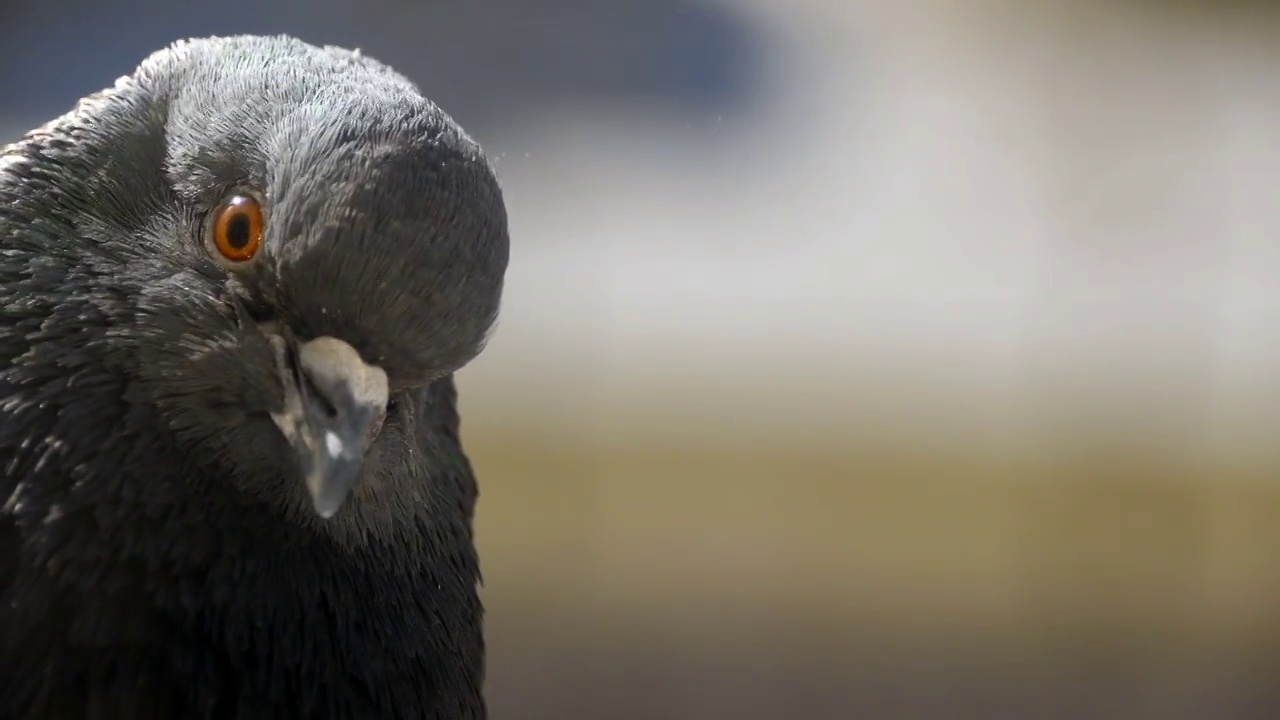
<box><xmin>0</xmin><ymin>0</ymin><xmax>1280</xmax><ymax>720</ymax></box>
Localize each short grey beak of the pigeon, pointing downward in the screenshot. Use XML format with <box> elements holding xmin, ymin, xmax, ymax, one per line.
<box><xmin>271</xmin><ymin>334</ymin><xmax>388</xmax><ymax>518</ymax></box>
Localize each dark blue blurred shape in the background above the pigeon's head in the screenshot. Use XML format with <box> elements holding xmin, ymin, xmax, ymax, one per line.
<box><xmin>0</xmin><ymin>0</ymin><xmax>760</xmax><ymax>132</ymax></box>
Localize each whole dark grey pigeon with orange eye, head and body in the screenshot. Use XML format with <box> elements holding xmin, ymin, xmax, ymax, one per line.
<box><xmin>0</xmin><ymin>35</ymin><xmax>509</xmax><ymax>720</ymax></box>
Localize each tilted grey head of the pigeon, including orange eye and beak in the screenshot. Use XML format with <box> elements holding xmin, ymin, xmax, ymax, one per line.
<box><xmin>0</xmin><ymin>37</ymin><xmax>508</xmax><ymax>518</ymax></box>
